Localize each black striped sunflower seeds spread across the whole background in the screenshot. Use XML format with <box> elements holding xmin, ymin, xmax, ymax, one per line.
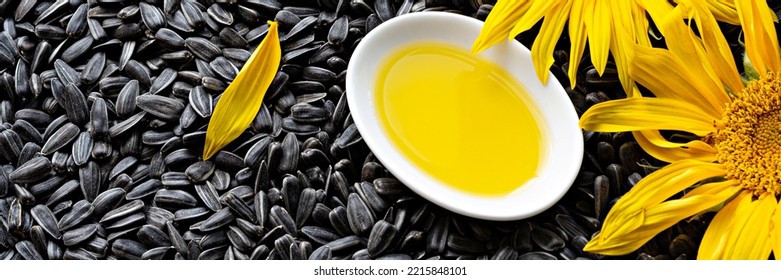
<box><xmin>0</xmin><ymin>0</ymin><xmax>706</xmax><ymax>259</ymax></box>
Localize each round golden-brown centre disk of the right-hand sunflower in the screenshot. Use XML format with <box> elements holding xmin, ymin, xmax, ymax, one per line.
<box><xmin>715</xmin><ymin>73</ymin><xmax>781</xmax><ymax>196</ymax></box>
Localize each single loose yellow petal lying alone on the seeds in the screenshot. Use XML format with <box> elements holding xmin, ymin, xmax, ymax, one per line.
<box><xmin>203</xmin><ymin>21</ymin><xmax>282</xmax><ymax>160</ymax></box>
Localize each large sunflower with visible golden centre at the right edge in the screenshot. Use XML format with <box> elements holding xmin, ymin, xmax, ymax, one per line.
<box><xmin>580</xmin><ymin>0</ymin><xmax>781</xmax><ymax>259</ymax></box>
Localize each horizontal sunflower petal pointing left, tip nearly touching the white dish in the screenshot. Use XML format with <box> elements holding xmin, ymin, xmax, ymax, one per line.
<box><xmin>580</xmin><ymin>98</ymin><xmax>714</xmax><ymax>136</ymax></box>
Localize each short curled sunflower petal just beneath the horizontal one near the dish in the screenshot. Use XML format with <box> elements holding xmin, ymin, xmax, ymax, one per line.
<box><xmin>632</xmin><ymin>130</ymin><xmax>716</xmax><ymax>162</ymax></box>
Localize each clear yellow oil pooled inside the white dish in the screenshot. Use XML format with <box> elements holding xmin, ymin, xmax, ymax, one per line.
<box><xmin>374</xmin><ymin>42</ymin><xmax>545</xmax><ymax>196</ymax></box>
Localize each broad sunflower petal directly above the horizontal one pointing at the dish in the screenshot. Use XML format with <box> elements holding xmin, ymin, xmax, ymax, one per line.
<box><xmin>629</xmin><ymin>44</ymin><xmax>729</xmax><ymax>119</ymax></box>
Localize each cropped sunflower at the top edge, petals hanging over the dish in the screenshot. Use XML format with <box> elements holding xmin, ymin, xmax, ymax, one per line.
<box><xmin>472</xmin><ymin>0</ymin><xmax>738</xmax><ymax>92</ymax></box>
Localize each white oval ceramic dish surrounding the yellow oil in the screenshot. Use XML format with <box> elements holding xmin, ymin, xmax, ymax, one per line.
<box><xmin>347</xmin><ymin>12</ymin><xmax>583</xmax><ymax>221</ymax></box>
